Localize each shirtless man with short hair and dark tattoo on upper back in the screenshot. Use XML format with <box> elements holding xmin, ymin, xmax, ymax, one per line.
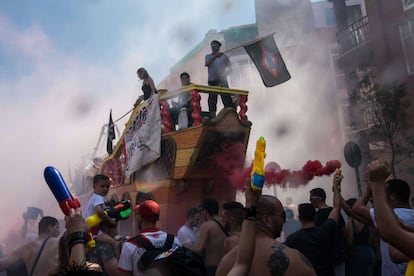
<box><xmin>216</xmin><ymin>195</ymin><xmax>316</xmax><ymax>276</ymax></box>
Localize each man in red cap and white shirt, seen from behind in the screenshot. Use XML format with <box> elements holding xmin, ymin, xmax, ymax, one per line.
<box><xmin>118</xmin><ymin>200</ymin><xmax>181</xmax><ymax>276</ymax></box>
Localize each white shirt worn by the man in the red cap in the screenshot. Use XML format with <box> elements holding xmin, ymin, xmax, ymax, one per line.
<box><xmin>118</xmin><ymin>228</ymin><xmax>181</xmax><ymax>276</ymax></box>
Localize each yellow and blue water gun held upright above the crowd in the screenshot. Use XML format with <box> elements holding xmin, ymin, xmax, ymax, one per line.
<box><xmin>250</xmin><ymin>136</ymin><xmax>266</xmax><ymax>192</ymax></box>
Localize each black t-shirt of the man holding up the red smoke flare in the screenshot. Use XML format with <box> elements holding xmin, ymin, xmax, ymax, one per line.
<box><xmin>315</xmin><ymin>207</ymin><xmax>346</xmax><ymax>265</ymax></box>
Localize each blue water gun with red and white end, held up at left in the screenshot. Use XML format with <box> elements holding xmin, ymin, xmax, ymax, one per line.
<box><xmin>43</xmin><ymin>166</ymin><xmax>95</xmax><ymax>248</ymax></box>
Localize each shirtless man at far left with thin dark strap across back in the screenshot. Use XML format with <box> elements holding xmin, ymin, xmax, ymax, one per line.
<box><xmin>0</xmin><ymin>216</ymin><xmax>60</xmax><ymax>276</ymax></box>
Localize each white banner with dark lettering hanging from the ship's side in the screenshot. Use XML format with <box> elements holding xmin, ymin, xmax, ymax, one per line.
<box><xmin>125</xmin><ymin>94</ymin><xmax>161</xmax><ymax>177</ymax></box>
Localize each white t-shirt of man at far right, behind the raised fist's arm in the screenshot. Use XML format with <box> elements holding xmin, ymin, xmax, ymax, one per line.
<box><xmin>370</xmin><ymin>208</ymin><xmax>414</xmax><ymax>276</ymax></box>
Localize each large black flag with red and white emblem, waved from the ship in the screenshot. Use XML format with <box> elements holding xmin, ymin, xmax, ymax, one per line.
<box><xmin>244</xmin><ymin>34</ymin><xmax>290</xmax><ymax>87</ymax></box>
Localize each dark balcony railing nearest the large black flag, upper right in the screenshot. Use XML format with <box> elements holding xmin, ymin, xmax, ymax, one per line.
<box><xmin>338</xmin><ymin>16</ymin><xmax>369</xmax><ymax>54</ymax></box>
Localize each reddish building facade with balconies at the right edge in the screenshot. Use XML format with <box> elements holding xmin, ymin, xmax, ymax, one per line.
<box><xmin>331</xmin><ymin>0</ymin><xmax>414</xmax><ymax>187</ymax></box>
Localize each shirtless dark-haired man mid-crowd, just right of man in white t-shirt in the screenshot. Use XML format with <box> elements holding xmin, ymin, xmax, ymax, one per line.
<box><xmin>191</xmin><ymin>198</ymin><xmax>227</xmax><ymax>276</ymax></box>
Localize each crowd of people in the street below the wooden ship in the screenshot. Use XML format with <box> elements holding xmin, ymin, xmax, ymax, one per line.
<box><xmin>0</xmin><ymin>160</ymin><xmax>414</xmax><ymax>276</ymax></box>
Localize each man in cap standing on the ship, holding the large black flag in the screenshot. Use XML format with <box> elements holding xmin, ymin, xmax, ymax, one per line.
<box><xmin>205</xmin><ymin>40</ymin><xmax>234</xmax><ymax>117</ymax></box>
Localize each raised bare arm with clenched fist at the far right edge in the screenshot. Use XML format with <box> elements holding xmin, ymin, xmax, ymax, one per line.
<box><xmin>368</xmin><ymin>160</ymin><xmax>414</xmax><ymax>259</ymax></box>
